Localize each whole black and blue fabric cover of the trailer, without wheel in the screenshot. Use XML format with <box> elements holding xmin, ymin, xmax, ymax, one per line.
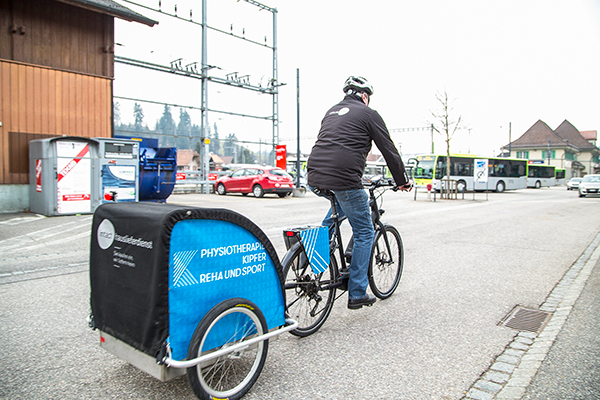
<box><xmin>90</xmin><ymin>202</ymin><xmax>285</xmax><ymax>360</ymax></box>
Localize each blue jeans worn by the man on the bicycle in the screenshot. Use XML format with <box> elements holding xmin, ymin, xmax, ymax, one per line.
<box><xmin>311</xmin><ymin>188</ymin><xmax>374</xmax><ymax>300</ymax></box>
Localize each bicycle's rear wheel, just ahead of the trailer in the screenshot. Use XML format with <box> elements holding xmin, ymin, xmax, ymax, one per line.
<box><xmin>282</xmin><ymin>245</ymin><xmax>338</xmax><ymax>337</ymax></box>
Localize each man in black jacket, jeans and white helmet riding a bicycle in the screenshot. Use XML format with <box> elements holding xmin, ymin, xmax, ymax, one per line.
<box><xmin>307</xmin><ymin>76</ymin><xmax>412</xmax><ymax>309</ymax></box>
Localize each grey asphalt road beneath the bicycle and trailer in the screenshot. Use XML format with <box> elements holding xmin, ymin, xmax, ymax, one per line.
<box><xmin>0</xmin><ymin>187</ymin><xmax>600</xmax><ymax>400</ymax></box>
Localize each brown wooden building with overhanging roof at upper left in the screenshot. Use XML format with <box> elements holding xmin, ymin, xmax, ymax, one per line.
<box><xmin>0</xmin><ymin>0</ymin><xmax>157</xmax><ymax>212</ymax></box>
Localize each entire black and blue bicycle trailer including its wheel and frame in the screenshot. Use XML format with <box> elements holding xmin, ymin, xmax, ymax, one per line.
<box><xmin>89</xmin><ymin>203</ymin><xmax>297</xmax><ymax>399</ymax></box>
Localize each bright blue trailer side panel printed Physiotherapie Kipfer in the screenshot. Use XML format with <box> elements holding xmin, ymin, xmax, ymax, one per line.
<box><xmin>169</xmin><ymin>220</ymin><xmax>285</xmax><ymax>360</ymax></box>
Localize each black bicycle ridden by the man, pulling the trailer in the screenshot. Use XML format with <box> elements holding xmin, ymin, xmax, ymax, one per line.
<box><xmin>282</xmin><ymin>179</ymin><xmax>404</xmax><ymax>337</ymax></box>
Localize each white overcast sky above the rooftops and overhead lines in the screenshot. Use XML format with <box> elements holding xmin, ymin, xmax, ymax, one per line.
<box><xmin>114</xmin><ymin>0</ymin><xmax>600</xmax><ymax>156</ymax></box>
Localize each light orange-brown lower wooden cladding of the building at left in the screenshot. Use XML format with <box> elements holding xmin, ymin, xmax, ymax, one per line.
<box><xmin>0</xmin><ymin>60</ymin><xmax>112</xmax><ymax>184</ymax></box>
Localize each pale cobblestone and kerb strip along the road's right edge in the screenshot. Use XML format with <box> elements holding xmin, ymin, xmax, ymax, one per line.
<box><xmin>462</xmin><ymin>233</ymin><xmax>600</xmax><ymax>400</ymax></box>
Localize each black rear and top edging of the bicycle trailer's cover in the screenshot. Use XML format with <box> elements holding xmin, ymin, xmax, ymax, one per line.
<box><xmin>90</xmin><ymin>202</ymin><xmax>285</xmax><ymax>357</ymax></box>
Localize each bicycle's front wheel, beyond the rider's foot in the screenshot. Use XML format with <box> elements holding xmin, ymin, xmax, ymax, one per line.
<box><xmin>368</xmin><ymin>225</ymin><xmax>404</xmax><ymax>299</ymax></box>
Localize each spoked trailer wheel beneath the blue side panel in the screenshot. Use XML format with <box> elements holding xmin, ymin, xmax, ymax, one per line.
<box><xmin>187</xmin><ymin>298</ymin><xmax>269</xmax><ymax>400</ymax></box>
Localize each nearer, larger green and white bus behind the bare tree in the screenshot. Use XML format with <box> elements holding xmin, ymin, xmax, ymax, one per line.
<box><xmin>413</xmin><ymin>154</ymin><xmax>527</xmax><ymax>192</ymax></box>
